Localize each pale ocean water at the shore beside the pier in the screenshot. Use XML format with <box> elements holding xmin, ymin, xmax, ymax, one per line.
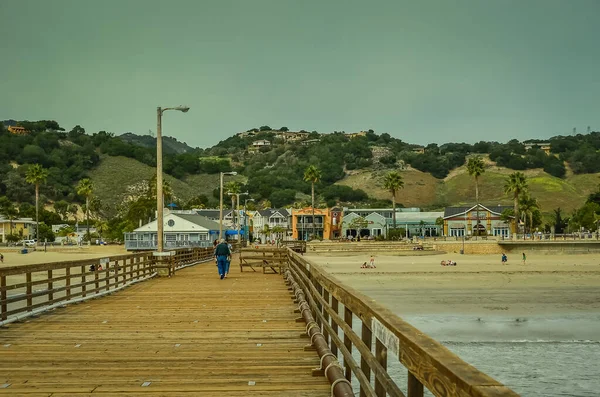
<box><xmin>400</xmin><ymin>313</ymin><xmax>600</xmax><ymax>397</ymax></box>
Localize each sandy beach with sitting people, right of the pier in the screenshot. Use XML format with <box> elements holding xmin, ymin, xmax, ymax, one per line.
<box><xmin>306</xmin><ymin>254</ymin><xmax>600</xmax><ymax>315</ymax></box>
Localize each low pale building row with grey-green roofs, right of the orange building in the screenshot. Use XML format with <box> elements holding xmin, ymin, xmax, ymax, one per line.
<box><xmin>342</xmin><ymin>207</ymin><xmax>444</xmax><ymax>237</ymax></box>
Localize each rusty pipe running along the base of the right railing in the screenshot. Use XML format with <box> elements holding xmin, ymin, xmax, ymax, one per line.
<box><xmin>284</xmin><ymin>269</ymin><xmax>354</xmax><ymax>397</ymax></box>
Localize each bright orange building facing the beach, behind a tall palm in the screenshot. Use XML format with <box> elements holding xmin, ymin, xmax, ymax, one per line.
<box><xmin>292</xmin><ymin>207</ymin><xmax>343</xmax><ymax>240</ymax></box>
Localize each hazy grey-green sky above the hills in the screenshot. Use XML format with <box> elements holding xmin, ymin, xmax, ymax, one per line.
<box><xmin>0</xmin><ymin>0</ymin><xmax>600</xmax><ymax>147</ymax></box>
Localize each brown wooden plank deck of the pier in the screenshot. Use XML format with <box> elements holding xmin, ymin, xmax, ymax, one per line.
<box><xmin>0</xmin><ymin>255</ymin><xmax>330</xmax><ymax>397</ymax></box>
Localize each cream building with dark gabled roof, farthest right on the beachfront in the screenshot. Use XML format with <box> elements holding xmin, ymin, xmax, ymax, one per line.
<box><xmin>444</xmin><ymin>204</ymin><xmax>514</xmax><ymax>238</ymax></box>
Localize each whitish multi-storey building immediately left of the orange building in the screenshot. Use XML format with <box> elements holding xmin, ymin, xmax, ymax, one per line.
<box><xmin>252</xmin><ymin>208</ymin><xmax>292</xmax><ymax>243</ymax></box>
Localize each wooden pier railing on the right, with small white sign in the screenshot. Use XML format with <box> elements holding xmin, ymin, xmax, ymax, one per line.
<box><xmin>288</xmin><ymin>250</ymin><xmax>517</xmax><ymax>397</ymax></box>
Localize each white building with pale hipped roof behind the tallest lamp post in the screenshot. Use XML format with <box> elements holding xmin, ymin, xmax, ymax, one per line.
<box><xmin>125</xmin><ymin>211</ymin><xmax>223</xmax><ymax>251</ymax></box>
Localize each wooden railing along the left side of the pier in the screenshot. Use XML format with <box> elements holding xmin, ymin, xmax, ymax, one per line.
<box><xmin>0</xmin><ymin>247</ymin><xmax>213</xmax><ymax>324</ymax></box>
